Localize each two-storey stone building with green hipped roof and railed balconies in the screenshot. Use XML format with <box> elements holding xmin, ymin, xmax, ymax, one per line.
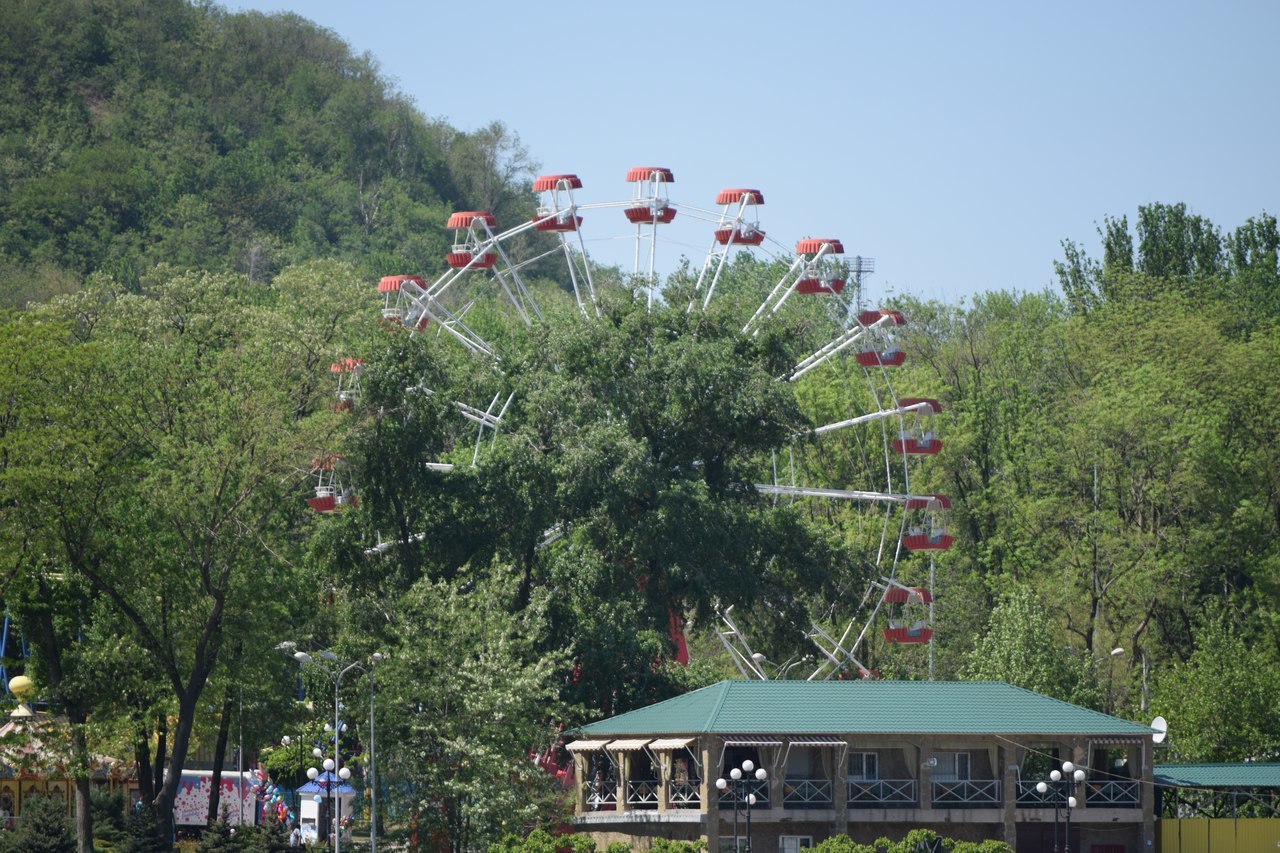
<box><xmin>567</xmin><ymin>680</ymin><xmax>1155</xmax><ymax>853</ymax></box>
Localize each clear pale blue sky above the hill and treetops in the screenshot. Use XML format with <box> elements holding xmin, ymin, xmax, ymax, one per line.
<box><xmin>225</xmin><ymin>0</ymin><xmax>1280</xmax><ymax>302</ymax></box>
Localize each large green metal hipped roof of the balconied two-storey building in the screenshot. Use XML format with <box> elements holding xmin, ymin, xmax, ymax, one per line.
<box><xmin>579</xmin><ymin>680</ymin><xmax>1152</xmax><ymax>738</ymax></box>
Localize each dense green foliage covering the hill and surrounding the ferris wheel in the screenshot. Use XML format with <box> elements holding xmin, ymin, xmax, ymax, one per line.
<box><xmin>0</xmin><ymin>0</ymin><xmax>1280</xmax><ymax>849</ymax></box>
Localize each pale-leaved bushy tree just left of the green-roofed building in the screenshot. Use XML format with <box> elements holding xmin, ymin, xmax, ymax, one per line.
<box><xmin>378</xmin><ymin>566</ymin><xmax>567</xmax><ymax>850</ymax></box>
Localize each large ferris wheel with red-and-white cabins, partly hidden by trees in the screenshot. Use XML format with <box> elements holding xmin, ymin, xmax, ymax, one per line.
<box><xmin>366</xmin><ymin>167</ymin><xmax>952</xmax><ymax>679</ymax></box>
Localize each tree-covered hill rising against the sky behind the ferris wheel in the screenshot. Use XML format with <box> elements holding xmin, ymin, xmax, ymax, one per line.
<box><xmin>0</xmin><ymin>0</ymin><xmax>527</xmax><ymax>306</ymax></box>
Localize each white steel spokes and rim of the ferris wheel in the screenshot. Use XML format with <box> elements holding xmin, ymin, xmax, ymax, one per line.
<box><xmin>378</xmin><ymin>167</ymin><xmax>946</xmax><ymax>679</ymax></box>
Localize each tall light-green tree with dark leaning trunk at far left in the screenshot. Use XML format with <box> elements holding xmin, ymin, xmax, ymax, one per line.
<box><xmin>9</xmin><ymin>266</ymin><xmax>348</xmax><ymax>835</ymax></box>
